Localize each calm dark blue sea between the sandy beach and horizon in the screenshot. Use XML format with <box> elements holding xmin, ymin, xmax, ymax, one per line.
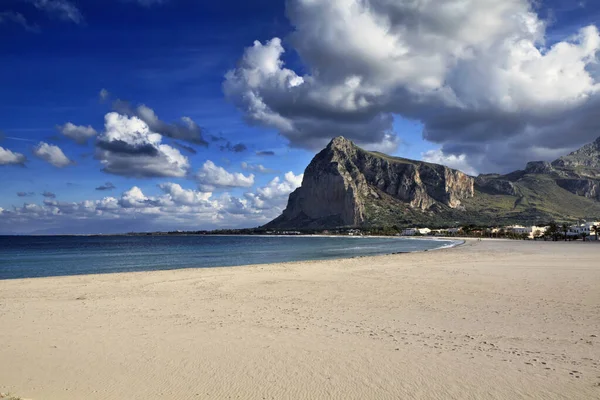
<box><xmin>0</xmin><ymin>236</ymin><xmax>458</xmax><ymax>279</ymax></box>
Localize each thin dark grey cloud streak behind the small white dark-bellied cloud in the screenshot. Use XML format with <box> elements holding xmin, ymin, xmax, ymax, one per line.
<box><xmin>113</xmin><ymin>100</ymin><xmax>208</xmax><ymax>146</ymax></box>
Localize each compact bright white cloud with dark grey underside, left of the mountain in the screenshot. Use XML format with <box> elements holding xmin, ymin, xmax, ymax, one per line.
<box><xmin>96</xmin><ymin>112</ymin><xmax>190</xmax><ymax>178</ymax></box>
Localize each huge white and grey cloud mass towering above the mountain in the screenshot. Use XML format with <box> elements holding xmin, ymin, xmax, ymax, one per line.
<box><xmin>223</xmin><ymin>0</ymin><xmax>600</xmax><ymax>171</ymax></box>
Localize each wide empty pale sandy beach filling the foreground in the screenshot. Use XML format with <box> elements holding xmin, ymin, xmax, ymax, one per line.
<box><xmin>0</xmin><ymin>241</ymin><xmax>600</xmax><ymax>400</ymax></box>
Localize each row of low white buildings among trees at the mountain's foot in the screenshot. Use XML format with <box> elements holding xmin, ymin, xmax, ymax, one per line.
<box><xmin>401</xmin><ymin>222</ymin><xmax>600</xmax><ymax>240</ymax></box>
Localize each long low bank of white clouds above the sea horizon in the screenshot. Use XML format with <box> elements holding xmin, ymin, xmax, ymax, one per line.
<box><xmin>0</xmin><ymin>174</ymin><xmax>299</xmax><ymax>233</ymax></box>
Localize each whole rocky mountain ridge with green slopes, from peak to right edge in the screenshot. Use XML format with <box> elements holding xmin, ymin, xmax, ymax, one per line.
<box><xmin>265</xmin><ymin>137</ymin><xmax>600</xmax><ymax>229</ymax></box>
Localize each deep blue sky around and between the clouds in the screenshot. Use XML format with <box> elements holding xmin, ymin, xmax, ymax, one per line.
<box><xmin>0</xmin><ymin>0</ymin><xmax>600</xmax><ymax>233</ymax></box>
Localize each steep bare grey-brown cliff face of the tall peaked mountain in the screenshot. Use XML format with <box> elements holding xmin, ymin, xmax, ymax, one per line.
<box><xmin>267</xmin><ymin>137</ymin><xmax>475</xmax><ymax>228</ymax></box>
